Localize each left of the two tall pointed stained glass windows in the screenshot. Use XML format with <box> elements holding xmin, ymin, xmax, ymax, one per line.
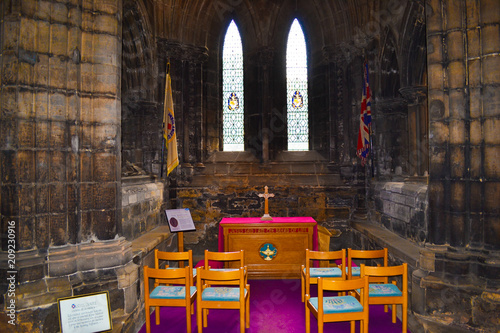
<box><xmin>222</xmin><ymin>21</ymin><xmax>244</xmax><ymax>151</ymax></box>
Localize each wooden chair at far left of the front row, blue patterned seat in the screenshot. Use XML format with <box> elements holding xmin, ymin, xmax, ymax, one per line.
<box><xmin>144</xmin><ymin>266</ymin><xmax>197</xmax><ymax>333</ymax></box>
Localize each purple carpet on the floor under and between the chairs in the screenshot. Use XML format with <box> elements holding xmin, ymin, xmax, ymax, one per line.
<box><xmin>139</xmin><ymin>280</ymin><xmax>409</xmax><ymax>333</ymax></box>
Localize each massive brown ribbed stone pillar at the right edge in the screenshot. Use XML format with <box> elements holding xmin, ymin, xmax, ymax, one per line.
<box><xmin>421</xmin><ymin>0</ymin><xmax>500</xmax><ymax>331</ymax></box>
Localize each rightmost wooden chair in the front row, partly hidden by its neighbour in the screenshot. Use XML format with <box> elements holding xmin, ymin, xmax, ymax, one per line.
<box><xmin>361</xmin><ymin>263</ymin><xmax>408</xmax><ymax>333</ymax></box>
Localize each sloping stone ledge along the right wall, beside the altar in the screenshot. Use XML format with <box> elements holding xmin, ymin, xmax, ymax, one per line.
<box><xmin>351</xmin><ymin>220</ymin><xmax>422</xmax><ymax>268</ymax></box>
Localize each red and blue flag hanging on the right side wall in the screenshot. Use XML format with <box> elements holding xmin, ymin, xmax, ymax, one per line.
<box><xmin>356</xmin><ymin>61</ymin><xmax>372</xmax><ymax>166</ymax></box>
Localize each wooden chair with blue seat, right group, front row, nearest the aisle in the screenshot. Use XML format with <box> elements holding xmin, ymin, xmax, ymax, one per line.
<box><xmin>306</xmin><ymin>277</ymin><xmax>369</xmax><ymax>333</ymax></box>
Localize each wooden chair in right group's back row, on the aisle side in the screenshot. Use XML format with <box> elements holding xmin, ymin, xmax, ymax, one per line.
<box><xmin>300</xmin><ymin>249</ymin><xmax>346</xmax><ymax>302</ymax></box>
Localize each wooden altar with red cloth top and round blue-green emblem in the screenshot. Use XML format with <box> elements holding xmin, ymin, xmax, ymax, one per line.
<box><xmin>219</xmin><ymin>217</ymin><xmax>318</xmax><ymax>279</ymax></box>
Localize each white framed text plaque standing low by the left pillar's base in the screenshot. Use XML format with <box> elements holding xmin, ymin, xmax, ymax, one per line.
<box><xmin>57</xmin><ymin>291</ymin><xmax>113</xmax><ymax>333</ymax></box>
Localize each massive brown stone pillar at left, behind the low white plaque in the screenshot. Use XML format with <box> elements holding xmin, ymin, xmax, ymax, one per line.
<box><xmin>0</xmin><ymin>0</ymin><xmax>141</xmax><ymax>332</ymax></box>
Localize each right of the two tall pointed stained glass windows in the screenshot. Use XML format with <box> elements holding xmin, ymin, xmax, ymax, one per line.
<box><xmin>286</xmin><ymin>19</ymin><xmax>309</xmax><ymax>150</ymax></box>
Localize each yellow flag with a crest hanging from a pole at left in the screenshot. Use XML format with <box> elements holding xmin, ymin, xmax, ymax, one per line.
<box><xmin>163</xmin><ymin>69</ymin><xmax>179</xmax><ymax>176</ymax></box>
